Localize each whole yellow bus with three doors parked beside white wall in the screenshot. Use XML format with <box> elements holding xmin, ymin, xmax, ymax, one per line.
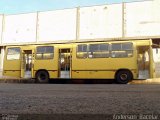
<box><xmin>3</xmin><ymin>40</ymin><xmax>155</xmax><ymax>84</ymax></box>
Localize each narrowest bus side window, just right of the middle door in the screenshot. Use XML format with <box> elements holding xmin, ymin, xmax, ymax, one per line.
<box><xmin>77</xmin><ymin>44</ymin><xmax>88</xmax><ymax>58</ymax></box>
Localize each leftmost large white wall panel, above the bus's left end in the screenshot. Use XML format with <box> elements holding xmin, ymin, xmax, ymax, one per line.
<box><xmin>2</xmin><ymin>13</ymin><xmax>37</xmax><ymax>44</ymax></box>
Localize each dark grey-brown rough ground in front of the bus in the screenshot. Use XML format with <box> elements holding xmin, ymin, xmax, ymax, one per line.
<box><xmin>0</xmin><ymin>83</ymin><xmax>160</xmax><ymax>120</ymax></box>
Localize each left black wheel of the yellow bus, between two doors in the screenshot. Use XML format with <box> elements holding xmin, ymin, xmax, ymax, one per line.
<box><xmin>36</xmin><ymin>71</ymin><xmax>49</xmax><ymax>83</ymax></box>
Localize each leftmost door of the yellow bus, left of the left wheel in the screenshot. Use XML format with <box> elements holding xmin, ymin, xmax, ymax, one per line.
<box><xmin>21</xmin><ymin>50</ymin><xmax>33</xmax><ymax>78</ymax></box>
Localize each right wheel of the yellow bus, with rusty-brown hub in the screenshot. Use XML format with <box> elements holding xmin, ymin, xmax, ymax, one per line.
<box><xmin>116</xmin><ymin>70</ymin><xmax>132</xmax><ymax>84</ymax></box>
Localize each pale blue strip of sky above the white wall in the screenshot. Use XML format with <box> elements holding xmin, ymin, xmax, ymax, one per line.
<box><xmin>0</xmin><ymin>0</ymin><xmax>140</xmax><ymax>14</ymax></box>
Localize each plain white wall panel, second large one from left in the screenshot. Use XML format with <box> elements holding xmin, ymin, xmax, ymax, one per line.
<box><xmin>38</xmin><ymin>9</ymin><xmax>77</xmax><ymax>42</ymax></box>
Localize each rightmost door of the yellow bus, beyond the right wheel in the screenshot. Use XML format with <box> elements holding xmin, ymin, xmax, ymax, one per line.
<box><xmin>137</xmin><ymin>46</ymin><xmax>150</xmax><ymax>79</ymax></box>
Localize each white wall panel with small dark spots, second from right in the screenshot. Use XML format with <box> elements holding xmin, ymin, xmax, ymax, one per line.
<box><xmin>79</xmin><ymin>4</ymin><xmax>122</xmax><ymax>39</ymax></box>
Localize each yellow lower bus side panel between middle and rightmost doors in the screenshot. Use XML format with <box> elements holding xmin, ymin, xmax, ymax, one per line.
<box><xmin>72</xmin><ymin>44</ymin><xmax>138</xmax><ymax>79</ymax></box>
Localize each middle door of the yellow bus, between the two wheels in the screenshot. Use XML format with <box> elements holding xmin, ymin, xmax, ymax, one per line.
<box><xmin>59</xmin><ymin>49</ymin><xmax>71</xmax><ymax>78</ymax></box>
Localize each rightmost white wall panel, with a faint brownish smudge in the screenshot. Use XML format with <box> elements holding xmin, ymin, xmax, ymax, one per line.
<box><xmin>125</xmin><ymin>1</ymin><xmax>160</xmax><ymax>37</ymax></box>
